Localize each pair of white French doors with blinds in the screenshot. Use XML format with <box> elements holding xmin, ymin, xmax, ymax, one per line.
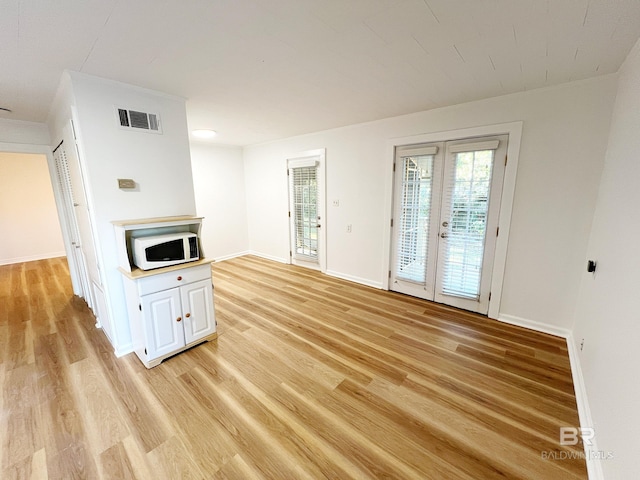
<box><xmin>390</xmin><ymin>135</ymin><xmax>508</xmax><ymax>314</ymax></box>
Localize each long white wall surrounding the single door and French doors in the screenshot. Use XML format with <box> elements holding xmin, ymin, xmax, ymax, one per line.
<box><xmin>244</xmin><ymin>76</ymin><xmax>616</xmax><ymax>330</ymax></box>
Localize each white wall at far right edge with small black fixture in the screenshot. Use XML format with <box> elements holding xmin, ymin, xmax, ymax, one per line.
<box><xmin>573</xmin><ymin>38</ymin><xmax>640</xmax><ymax>479</ymax></box>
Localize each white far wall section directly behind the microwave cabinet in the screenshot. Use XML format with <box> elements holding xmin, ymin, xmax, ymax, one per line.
<box><xmin>191</xmin><ymin>142</ymin><xmax>249</xmax><ymax>260</ymax></box>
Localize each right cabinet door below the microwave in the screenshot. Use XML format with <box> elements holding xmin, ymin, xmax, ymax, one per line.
<box><xmin>180</xmin><ymin>279</ymin><xmax>216</xmax><ymax>344</ymax></box>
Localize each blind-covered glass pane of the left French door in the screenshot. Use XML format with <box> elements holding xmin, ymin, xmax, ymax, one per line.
<box><xmin>396</xmin><ymin>155</ymin><xmax>433</xmax><ymax>284</ymax></box>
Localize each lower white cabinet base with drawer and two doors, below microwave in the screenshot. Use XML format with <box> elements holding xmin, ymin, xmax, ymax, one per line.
<box><xmin>124</xmin><ymin>262</ymin><xmax>217</xmax><ymax>368</ymax></box>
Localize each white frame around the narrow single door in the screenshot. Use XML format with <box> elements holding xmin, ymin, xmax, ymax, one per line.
<box><xmin>286</xmin><ymin>148</ymin><xmax>327</xmax><ymax>273</ymax></box>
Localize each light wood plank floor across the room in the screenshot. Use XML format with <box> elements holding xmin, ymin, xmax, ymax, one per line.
<box><xmin>0</xmin><ymin>257</ymin><xmax>586</xmax><ymax>480</ymax></box>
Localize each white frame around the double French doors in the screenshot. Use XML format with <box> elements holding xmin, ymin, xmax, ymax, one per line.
<box><xmin>381</xmin><ymin>121</ymin><xmax>523</xmax><ymax>319</ymax></box>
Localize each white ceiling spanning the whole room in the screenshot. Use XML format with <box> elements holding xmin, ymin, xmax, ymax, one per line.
<box><xmin>0</xmin><ymin>0</ymin><xmax>640</xmax><ymax>145</ymax></box>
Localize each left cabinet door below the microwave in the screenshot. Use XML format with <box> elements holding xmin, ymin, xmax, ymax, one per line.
<box><xmin>141</xmin><ymin>288</ymin><xmax>185</xmax><ymax>360</ymax></box>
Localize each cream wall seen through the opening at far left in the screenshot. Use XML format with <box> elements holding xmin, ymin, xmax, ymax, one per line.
<box><xmin>0</xmin><ymin>152</ymin><xmax>65</xmax><ymax>265</ymax></box>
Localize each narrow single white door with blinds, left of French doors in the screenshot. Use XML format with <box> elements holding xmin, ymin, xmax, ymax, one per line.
<box><xmin>287</xmin><ymin>150</ymin><xmax>324</xmax><ymax>271</ymax></box>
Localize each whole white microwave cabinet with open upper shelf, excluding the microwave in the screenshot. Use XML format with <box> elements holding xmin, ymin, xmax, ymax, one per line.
<box><xmin>112</xmin><ymin>215</ymin><xmax>217</xmax><ymax>368</ymax></box>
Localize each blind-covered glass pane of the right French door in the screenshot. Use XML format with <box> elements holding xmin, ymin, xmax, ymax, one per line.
<box><xmin>441</xmin><ymin>150</ymin><xmax>495</xmax><ymax>299</ymax></box>
